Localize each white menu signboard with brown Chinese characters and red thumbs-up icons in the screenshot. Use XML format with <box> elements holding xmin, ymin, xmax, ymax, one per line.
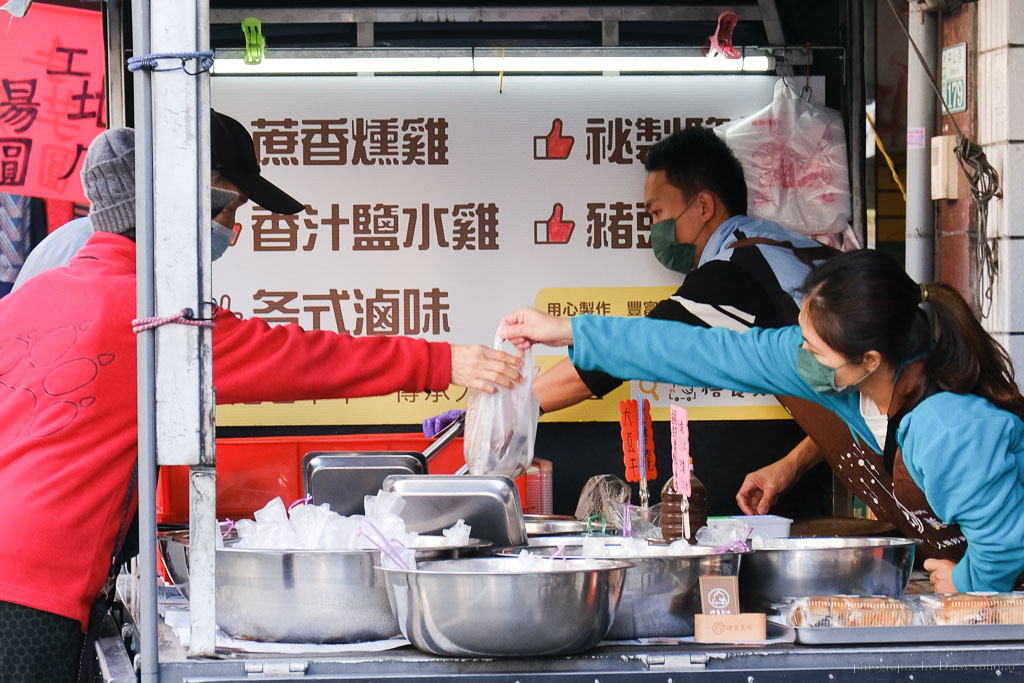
<box><xmin>212</xmin><ymin>75</ymin><xmax>798</xmax><ymax>424</ymax></box>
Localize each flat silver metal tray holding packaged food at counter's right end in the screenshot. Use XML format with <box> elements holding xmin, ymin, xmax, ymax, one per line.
<box><xmin>793</xmin><ymin>624</ymin><xmax>1024</xmax><ymax>645</ymax></box>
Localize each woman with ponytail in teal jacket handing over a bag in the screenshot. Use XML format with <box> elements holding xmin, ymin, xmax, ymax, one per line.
<box><xmin>502</xmin><ymin>250</ymin><xmax>1024</xmax><ymax>592</ymax></box>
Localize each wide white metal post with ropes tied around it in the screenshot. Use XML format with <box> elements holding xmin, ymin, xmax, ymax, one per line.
<box><xmin>150</xmin><ymin>0</ymin><xmax>217</xmax><ymax>655</ymax></box>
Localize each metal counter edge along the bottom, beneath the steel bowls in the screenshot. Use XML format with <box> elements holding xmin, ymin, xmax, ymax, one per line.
<box><xmin>98</xmin><ymin>606</ymin><xmax>1024</xmax><ymax>683</ymax></box>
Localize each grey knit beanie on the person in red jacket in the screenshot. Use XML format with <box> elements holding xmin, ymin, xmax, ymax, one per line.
<box><xmin>82</xmin><ymin>128</ymin><xmax>135</xmax><ymax>233</ymax></box>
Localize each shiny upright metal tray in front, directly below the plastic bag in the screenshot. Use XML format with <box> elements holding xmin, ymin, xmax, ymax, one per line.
<box><xmin>384</xmin><ymin>474</ymin><xmax>526</xmax><ymax>548</ymax></box>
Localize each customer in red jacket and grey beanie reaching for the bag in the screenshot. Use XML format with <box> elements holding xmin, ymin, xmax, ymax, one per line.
<box><xmin>0</xmin><ymin>128</ymin><xmax>519</xmax><ymax>682</ymax></box>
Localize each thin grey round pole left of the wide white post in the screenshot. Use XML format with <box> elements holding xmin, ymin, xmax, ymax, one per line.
<box><xmin>132</xmin><ymin>0</ymin><xmax>160</xmax><ymax>683</ymax></box>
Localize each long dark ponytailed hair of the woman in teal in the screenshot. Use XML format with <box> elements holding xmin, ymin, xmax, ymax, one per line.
<box><xmin>802</xmin><ymin>249</ymin><xmax>1024</xmax><ymax>419</ymax></box>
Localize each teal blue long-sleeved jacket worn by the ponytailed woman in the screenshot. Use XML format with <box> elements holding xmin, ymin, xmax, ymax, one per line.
<box><xmin>569</xmin><ymin>315</ymin><xmax>1024</xmax><ymax>592</ymax></box>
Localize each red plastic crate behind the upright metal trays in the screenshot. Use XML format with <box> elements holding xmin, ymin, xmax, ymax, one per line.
<box><xmin>157</xmin><ymin>432</ymin><xmax>526</xmax><ymax>523</ymax></box>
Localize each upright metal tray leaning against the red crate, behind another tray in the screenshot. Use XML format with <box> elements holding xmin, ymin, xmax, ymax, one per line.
<box><xmin>302</xmin><ymin>452</ymin><xmax>423</xmax><ymax>515</ymax></box>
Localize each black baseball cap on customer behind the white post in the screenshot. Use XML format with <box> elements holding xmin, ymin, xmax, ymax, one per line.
<box><xmin>210</xmin><ymin>110</ymin><xmax>305</xmax><ymax>214</ymax></box>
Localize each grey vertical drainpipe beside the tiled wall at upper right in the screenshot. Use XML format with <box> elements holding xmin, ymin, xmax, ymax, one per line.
<box><xmin>906</xmin><ymin>0</ymin><xmax>938</xmax><ymax>283</ymax></box>
